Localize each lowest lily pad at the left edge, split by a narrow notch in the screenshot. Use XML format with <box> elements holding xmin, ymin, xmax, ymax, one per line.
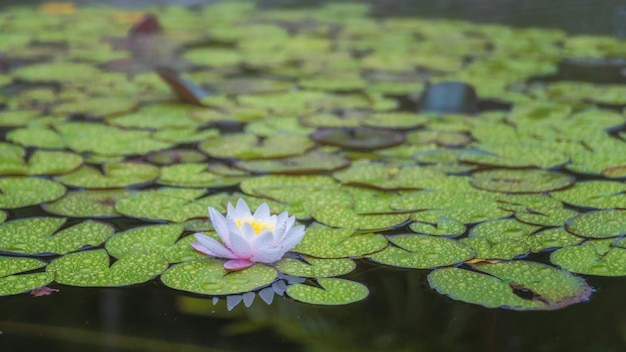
<box><xmin>0</xmin><ymin>257</ymin><xmax>54</xmax><ymax>296</ymax></box>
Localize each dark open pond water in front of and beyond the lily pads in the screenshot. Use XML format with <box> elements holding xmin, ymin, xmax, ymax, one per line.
<box><xmin>0</xmin><ymin>0</ymin><xmax>626</xmax><ymax>352</ymax></box>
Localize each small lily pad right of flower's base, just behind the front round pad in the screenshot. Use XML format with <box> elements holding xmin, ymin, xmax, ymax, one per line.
<box><xmin>275</xmin><ymin>257</ymin><xmax>356</xmax><ymax>278</ymax></box>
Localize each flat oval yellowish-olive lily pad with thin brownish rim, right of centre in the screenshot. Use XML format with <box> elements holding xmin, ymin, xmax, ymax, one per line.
<box><xmin>472</xmin><ymin>169</ymin><xmax>575</xmax><ymax>193</ymax></box>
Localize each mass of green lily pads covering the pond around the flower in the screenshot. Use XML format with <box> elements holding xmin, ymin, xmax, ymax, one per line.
<box><xmin>0</xmin><ymin>1</ymin><xmax>626</xmax><ymax>310</ymax></box>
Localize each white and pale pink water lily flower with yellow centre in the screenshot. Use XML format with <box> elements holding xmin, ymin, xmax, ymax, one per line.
<box><xmin>191</xmin><ymin>199</ymin><xmax>304</xmax><ymax>270</ymax></box>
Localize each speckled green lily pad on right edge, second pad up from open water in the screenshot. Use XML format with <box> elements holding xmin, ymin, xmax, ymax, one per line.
<box><xmin>565</xmin><ymin>210</ymin><xmax>626</xmax><ymax>238</ymax></box>
